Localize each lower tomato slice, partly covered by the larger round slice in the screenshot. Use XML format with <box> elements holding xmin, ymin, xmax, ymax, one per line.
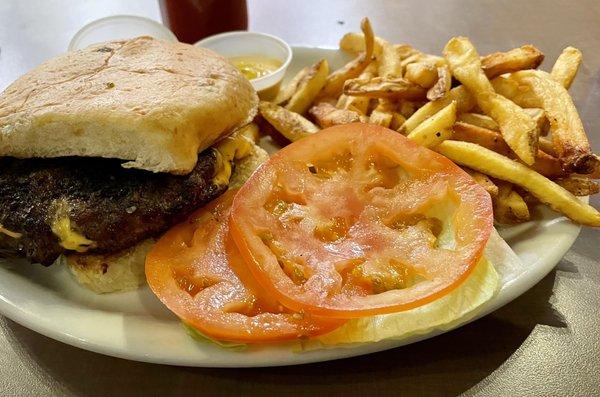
<box><xmin>146</xmin><ymin>191</ymin><xmax>343</xmax><ymax>343</ymax></box>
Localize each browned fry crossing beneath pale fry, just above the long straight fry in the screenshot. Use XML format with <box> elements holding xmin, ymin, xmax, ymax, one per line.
<box><xmin>452</xmin><ymin>122</ymin><xmax>565</xmax><ymax>178</ymax></box>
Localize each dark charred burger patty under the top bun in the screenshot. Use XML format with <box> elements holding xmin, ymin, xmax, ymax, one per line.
<box><xmin>0</xmin><ymin>149</ymin><xmax>227</xmax><ymax>265</ymax></box>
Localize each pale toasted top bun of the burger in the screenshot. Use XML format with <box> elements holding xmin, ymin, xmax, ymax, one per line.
<box><xmin>0</xmin><ymin>37</ymin><xmax>258</xmax><ymax>174</ymax></box>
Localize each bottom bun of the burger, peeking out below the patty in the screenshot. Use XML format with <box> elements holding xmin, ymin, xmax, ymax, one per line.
<box><xmin>66</xmin><ymin>145</ymin><xmax>269</xmax><ymax>294</ymax></box>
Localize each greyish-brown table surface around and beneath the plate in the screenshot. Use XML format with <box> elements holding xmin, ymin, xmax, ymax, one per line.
<box><xmin>0</xmin><ymin>0</ymin><xmax>600</xmax><ymax>396</ymax></box>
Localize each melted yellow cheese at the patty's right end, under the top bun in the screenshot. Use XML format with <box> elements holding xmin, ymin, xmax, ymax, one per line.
<box><xmin>213</xmin><ymin>124</ymin><xmax>256</xmax><ymax>186</ymax></box>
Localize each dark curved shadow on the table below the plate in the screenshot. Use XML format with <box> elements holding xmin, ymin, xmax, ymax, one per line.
<box><xmin>7</xmin><ymin>262</ymin><xmax>576</xmax><ymax>397</ymax></box>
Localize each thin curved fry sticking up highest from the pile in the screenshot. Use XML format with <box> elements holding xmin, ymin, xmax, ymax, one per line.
<box><xmin>319</xmin><ymin>18</ymin><xmax>375</xmax><ymax>98</ymax></box>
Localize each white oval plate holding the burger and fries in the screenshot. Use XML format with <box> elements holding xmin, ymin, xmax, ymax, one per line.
<box><xmin>0</xmin><ymin>47</ymin><xmax>580</xmax><ymax>367</ymax></box>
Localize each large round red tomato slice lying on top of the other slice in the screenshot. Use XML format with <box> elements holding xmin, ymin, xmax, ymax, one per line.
<box><xmin>230</xmin><ymin>123</ymin><xmax>492</xmax><ymax>318</ymax></box>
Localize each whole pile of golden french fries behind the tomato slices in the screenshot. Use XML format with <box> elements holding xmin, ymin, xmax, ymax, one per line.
<box><xmin>260</xmin><ymin>18</ymin><xmax>600</xmax><ymax>226</ymax></box>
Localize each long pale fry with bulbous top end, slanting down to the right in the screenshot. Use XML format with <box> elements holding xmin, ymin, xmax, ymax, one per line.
<box><xmin>444</xmin><ymin>37</ymin><xmax>538</xmax><ymax>165</ymax></box>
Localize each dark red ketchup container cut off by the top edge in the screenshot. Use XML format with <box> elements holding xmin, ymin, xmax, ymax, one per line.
<box><xmin>160</xmin><ymin>0</ymin><xmax>248</xmax><ymax>44</ymax></box>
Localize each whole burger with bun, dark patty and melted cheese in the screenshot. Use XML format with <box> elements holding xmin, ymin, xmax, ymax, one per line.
<box><xmin>0</xmin><ymin>37</ymin><xmax>268</xmax><ymax>292</ymax></box>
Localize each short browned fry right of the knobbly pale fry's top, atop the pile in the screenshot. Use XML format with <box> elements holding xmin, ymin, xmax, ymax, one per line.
<box><xmin>481</xmin><ymin>44</ymin><xmax>544</xmax><ymax>79</ymax></box>
